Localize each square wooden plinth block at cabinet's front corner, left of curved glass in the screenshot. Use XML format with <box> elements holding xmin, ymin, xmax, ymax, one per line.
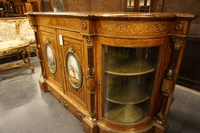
<box><xmin>82</xmin><ymin>117</ymin><xmax>97</xmax><ymax>133</ymax></box>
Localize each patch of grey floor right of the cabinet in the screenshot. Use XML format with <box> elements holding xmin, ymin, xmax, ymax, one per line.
<box><xmin>168</xmin><ymin>85</ymin><xmax>200</xmax><ymax>133</ymax></box>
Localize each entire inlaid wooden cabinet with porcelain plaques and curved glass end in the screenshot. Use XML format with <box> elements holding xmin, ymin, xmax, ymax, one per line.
<box><xmin>27</xmin><ymin>12</ymin><xmax>195</xmax><ymax>133</ymax></box>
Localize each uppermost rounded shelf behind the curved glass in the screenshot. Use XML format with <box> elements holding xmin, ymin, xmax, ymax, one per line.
<box><xmin>105</xmin><ymin>58</ymin><xmax>155</xmax><ymax>76</ymax></box>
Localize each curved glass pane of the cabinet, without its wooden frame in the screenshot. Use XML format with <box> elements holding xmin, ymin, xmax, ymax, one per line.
<box><xmin>103</xmin><ymin>45</ymin><xmax>159</xmax><ymax>124</ymax></box>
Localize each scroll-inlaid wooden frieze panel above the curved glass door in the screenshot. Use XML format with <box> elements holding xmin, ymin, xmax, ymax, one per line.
<box><xmin>97</xmin><ymin>20</ymin><xmax>172</xmax><ymax>38</ymax></box>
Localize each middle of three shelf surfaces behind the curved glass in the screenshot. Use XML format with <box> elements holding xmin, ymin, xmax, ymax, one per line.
<box><xmin>105</xmin><ymin>84</ymin><xmax>150</xmax><ymax>104</ymax></box>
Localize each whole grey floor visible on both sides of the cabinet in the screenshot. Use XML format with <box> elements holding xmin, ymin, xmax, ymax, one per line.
<box><xmin>0</xmin><ymin>57</ymin><xmax>200</xmax><ymax>133</ymax></box>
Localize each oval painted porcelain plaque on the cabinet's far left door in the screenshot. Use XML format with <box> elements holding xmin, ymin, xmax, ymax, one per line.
<box><xmin>46</xmin><ymin>43</ymin><xmax>56</xmax><ymax>73</ymax></box>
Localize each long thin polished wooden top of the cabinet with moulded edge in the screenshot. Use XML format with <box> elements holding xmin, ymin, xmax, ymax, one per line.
<box><xmin>26</xmin><ymin>12</ymin><xmax>197</xmax><ymax>19</ymax></box>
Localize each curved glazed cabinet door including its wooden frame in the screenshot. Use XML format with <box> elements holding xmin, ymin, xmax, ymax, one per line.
<box><xmin>97</xmin><ymin>38</ymin><xmax>167</xmax><ymax>127</ymax></box>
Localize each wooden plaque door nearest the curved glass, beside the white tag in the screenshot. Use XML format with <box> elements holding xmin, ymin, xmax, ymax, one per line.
<box><xmin>60</xmin><ymin>30</ymin><xmax>87</xmax><ymax>106</ymax></box>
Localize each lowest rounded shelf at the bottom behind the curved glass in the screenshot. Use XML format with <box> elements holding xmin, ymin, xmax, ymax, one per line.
<box><xmin>105</xmin><ymin>105</ymin><xmax>145</xmax><ymax>123</ymax></box>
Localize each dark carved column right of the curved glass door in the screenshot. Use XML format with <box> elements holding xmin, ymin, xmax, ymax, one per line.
<box><xmin>155</xmin><ymin>36</ymin><xmax>185</xmax><ymax>130</ymax></box>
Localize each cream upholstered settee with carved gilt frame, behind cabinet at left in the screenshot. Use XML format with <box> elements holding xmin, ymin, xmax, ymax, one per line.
<box><xmin>0</xmin><ymin>17</ymin><xmax>36</xmax><ymax>71</ymax></box>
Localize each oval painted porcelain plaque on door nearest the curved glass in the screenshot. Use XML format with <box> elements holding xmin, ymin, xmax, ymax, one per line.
<box><xmin>66</xmin><ymin>52</ymin><xmax>82</xmax><ymax>89</ymax></box>
